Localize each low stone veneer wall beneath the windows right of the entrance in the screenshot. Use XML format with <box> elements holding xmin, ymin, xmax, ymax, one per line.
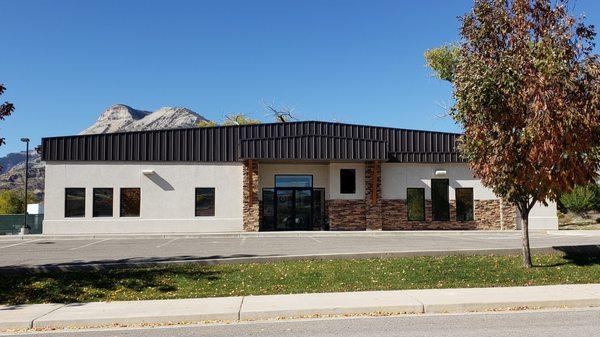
<box><xmin>382</xmin><ymin>200</ymin><xmax>516</xmax><ymax>230</ymax></box>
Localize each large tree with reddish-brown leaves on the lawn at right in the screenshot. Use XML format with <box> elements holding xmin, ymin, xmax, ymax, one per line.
<box><xmin>425</xmin><ymin>0</ymin><xmax>600</xmax><ymax>267</ymax></box>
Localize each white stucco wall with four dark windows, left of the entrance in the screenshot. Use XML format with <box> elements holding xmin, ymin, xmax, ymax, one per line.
<box><xmin>44</xmin><ymin>162</ymin><xmax>243</xmax><ymax>234</ymax></box>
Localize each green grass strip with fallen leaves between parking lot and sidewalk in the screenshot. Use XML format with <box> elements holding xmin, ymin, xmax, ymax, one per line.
<box><xmin>0</xmin><ymin>254</ymin><xmax>600</xmax><ymax>304</ymax></box>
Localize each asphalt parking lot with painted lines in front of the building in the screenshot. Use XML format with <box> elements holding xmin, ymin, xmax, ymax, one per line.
<box><xmin>0</xmin><ymin>231</ymin><xmax>600</xmax><ymax>268</ymax></box>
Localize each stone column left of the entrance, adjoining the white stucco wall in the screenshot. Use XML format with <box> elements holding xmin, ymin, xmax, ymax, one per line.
<box><xmin>243</xmin><ymin>160</ymin><xmax>259</xmax><ymax>232</ymax></box>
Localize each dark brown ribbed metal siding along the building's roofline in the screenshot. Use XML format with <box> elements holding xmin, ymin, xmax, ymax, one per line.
<box><xmin>42</xmin><ymin>121</ymin><xmax>461</xmax><ymax>163</ymax></box>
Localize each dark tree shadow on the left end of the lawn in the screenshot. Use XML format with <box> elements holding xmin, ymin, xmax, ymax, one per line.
<box><xmin>0</xmin><ymin>266</ymin><xmax>221</xmax><ymax>305</ymax></box>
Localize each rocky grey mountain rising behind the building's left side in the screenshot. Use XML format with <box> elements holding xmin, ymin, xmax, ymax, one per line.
<box><xmin>0</xmin><ymin>104</ymin><xmax>206</xmax><ymax>200</ymax></box>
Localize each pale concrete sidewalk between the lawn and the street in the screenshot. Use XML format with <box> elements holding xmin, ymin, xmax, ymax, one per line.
<box><xmin>0</xmin><ymin>284</ymin><xmax>600</xmax><ymax>330</ymax></box>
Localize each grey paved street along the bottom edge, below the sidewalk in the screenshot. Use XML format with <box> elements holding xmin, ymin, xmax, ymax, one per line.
<box><xmin>2</xmin><ymin>309</ymin><xmax>600</xmax><ymax>337</ymax></box>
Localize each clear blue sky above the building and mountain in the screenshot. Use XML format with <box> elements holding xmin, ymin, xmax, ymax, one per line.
<box><xmin>0</xmin><ymin>0</ymin><xmax>600</xmax><ymax>155</ymax></box>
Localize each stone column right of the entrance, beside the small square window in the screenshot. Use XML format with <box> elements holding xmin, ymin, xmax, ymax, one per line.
<box><xmin>365</xmin><ymin>161</ymin><xmax>383</xmax><ymax>230</ymax></box>
